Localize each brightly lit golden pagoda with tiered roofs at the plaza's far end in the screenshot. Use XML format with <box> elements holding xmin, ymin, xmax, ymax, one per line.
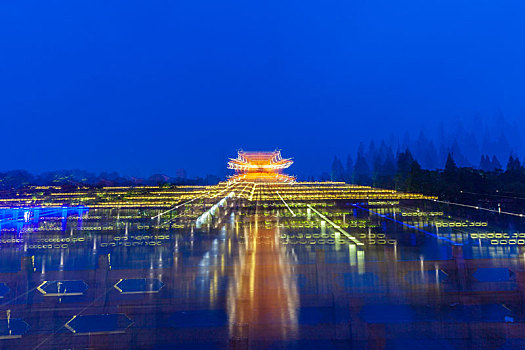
<box><xmin>228</xmin><ymin>150</ymin><xmax>295</xmax><ymax>183</ymax></box>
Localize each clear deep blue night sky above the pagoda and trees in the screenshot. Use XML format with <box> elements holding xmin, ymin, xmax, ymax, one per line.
<box><xmin>0</xmin><ymin>0</ymin><xmax>525</xmax><ymax>176</ymax></box>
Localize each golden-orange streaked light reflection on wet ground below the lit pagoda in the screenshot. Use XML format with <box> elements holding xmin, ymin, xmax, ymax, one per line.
<box><xmin>227</xmin><ymin>215</ymin><xmax>299</xmax><ymax>340</ymax></box>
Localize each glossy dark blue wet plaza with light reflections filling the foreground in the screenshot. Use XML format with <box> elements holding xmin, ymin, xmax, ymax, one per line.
<box><xmin>0</xmin><ymin>201</ymin><xmax>525</xmax><ymax>349</ymax></box>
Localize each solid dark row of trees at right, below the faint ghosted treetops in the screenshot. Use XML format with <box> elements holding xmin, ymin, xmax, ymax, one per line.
<box><xmin>330</xmin><ymin>147</ymin><xmax>525</xmax><ymax>200</ymax></box>
